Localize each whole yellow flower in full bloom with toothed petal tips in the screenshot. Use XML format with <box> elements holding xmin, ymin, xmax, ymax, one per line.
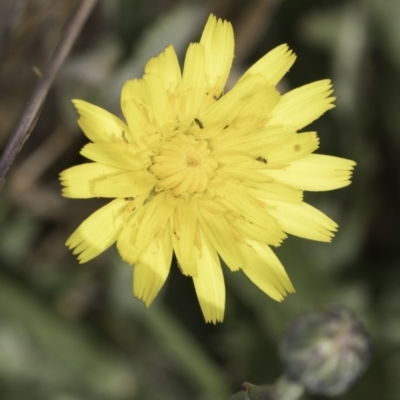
<box><xmin>61</xmin><ymin>15</ymin><xmax>355</xmax><ymax>323</ymax></box>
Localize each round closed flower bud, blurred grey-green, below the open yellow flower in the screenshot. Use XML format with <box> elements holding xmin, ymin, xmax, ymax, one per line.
<box><xmin>279</xmin><ymin>306</ymin><xmax>370</xmax><ymax>396</ymax></box>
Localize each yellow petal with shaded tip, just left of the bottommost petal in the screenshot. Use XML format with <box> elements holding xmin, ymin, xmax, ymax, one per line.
<box><xmin>133</xmin><ymin>229</ymin><xmax>172</xmax><ymax>307</ymax></box>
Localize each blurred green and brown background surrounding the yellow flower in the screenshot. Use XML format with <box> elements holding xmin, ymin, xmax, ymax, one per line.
<box><xmin>0</xmin><ymin>0</ymin><xmax>400</xmax><ymax>400</ymax></box>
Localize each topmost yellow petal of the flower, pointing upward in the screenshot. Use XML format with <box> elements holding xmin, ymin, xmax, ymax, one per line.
<box><xmin>200</xmin><ymin>15</ymin><xmax>235</xmax><ymax>97</ymax></box>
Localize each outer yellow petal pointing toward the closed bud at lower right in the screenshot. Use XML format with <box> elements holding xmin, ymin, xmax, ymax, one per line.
<box><xmin>239</xmin><ymin>240</ymin><xmax>294</xmax><ymax>301</ymax></box>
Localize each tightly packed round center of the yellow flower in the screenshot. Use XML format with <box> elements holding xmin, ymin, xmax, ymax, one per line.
<box><xmin>149</xmin><ymin>132</ymin><xmax>218</xmax><ymax>196</ymax></box>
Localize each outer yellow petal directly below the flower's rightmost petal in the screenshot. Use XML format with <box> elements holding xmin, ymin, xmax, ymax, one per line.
<box><xmin>269</xmin><ymin>202</ymin><xmax>338</xmax><ymax>242</ymax></box>
